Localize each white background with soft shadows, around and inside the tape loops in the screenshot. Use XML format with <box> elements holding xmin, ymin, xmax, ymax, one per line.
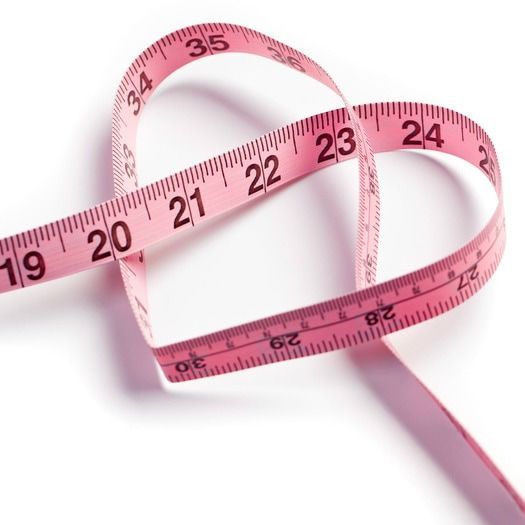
<box><xmin>0</xmin><ymin>0</ymin><xmax>525</xmax><ymax>525</ymax></box>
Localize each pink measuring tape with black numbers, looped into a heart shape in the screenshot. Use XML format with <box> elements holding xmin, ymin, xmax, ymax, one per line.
<box><xmin>0</xmin><ymin>24</ymin><xmax>525</xmax><ymax>514</ymax></box>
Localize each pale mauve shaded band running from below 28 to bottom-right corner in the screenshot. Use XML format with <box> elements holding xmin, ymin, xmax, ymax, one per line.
<box><xmin>346</xmin><ymin>342</ymin><xmax>525</xmax><ymax>525</ymax></box>
